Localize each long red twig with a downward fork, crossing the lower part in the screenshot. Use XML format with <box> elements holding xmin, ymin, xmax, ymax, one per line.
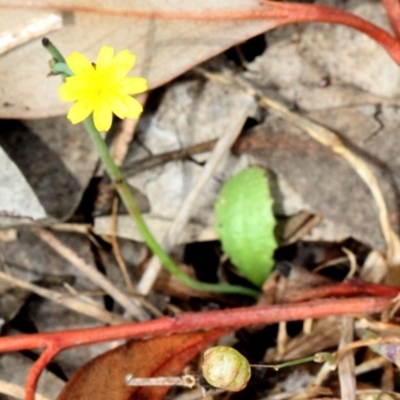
<box><xmin>0</xmin><ymin>297</ymin><xmax>391</xmax><ymax>400</ymax></box>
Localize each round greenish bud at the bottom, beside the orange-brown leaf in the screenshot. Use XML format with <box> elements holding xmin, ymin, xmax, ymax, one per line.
<box><xmin>202</xmin><ymin>346</ymin><xmax>251</xmax><ymax>392</ymax></box>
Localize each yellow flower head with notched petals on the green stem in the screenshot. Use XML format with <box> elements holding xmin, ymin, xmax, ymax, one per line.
<box><xmin>59</xmin><ymin>46</ymin><xmax>147</xmax><ymax>131</ymax></box>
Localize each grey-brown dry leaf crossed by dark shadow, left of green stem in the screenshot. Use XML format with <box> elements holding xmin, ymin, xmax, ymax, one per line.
<box><xmin>21</xmin><ymin>117</ymin><xmax>99</xmax><ymax>220</ymax></box>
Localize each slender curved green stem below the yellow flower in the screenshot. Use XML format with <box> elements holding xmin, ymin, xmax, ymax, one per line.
<box><xmin>84</xmin><ymin>116</ymin><xmax>260</xmax><ymax>297</ymax></box>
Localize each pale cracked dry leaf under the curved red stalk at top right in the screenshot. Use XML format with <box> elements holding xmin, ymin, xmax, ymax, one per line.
<box><xmin>245</xmin><ymin>0</ymin><xmax>400</xmax><ymax>101</ymax></box>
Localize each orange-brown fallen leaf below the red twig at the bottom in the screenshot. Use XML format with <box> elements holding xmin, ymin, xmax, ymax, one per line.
<box><xmin>57</xmin><ymin>330</ymin><xmax>227</xmax><ymax>400</ymax></box>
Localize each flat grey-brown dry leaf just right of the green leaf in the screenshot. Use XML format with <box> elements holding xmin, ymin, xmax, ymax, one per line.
<box><xmin>241</xmin><ymin>117</ymin><xmax>385</xmax><ymax>249</ymax></box>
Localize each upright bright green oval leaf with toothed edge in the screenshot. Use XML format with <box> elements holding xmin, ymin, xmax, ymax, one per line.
<box><xmin>215</xmin><ymin>167</ymin><xmax>277</xmax><ymax>286</ymax></box>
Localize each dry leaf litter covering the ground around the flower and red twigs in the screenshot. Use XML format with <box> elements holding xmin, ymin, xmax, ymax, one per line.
<box><xmin>0</xmin><ymin>1</ymin><xmax>399</xmax><ymax>399</ymax></box>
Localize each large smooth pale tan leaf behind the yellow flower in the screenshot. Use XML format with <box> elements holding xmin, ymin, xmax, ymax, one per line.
<box><xmin>0</xmin><ymin>0</ymin><xmax>277</xmax><ymax>118</ymax></box>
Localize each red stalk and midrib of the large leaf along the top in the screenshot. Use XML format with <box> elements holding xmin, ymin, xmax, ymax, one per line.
<box><xmin>0</xmin><ymin>0</ymin><xmax>400</xmax><ymax>64</ymax></box>
